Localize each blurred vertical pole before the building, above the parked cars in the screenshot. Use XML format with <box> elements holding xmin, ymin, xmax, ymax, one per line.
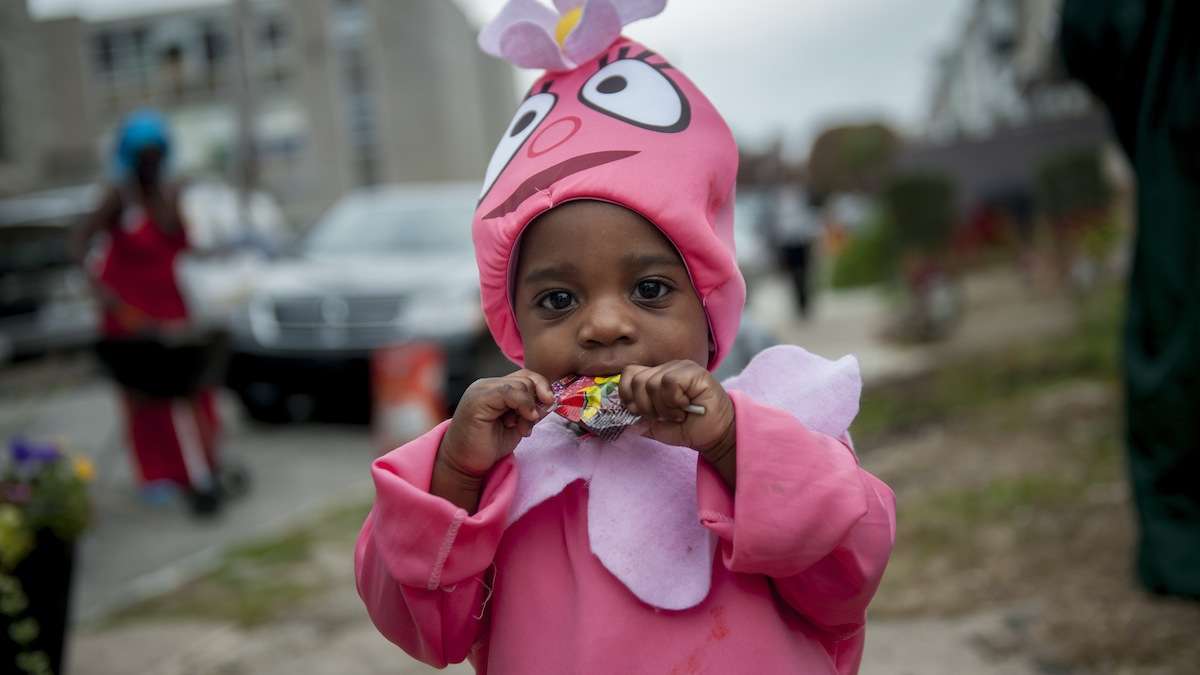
<box><xmin>230</xmin><ymin>0</ymin><xmax>258</xmax><ymax>235</ymax></box>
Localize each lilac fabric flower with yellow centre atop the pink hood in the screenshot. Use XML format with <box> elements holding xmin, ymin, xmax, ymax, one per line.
<box><xmin>479</xmin><ymin>0</ymin><xmax>667</xmax><ymax>71</ymax></box>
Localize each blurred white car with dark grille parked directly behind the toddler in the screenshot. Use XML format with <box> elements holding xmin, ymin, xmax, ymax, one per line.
<box><xmin>227</xmin><ymin>184</ymin><xmax>501</xmax><ymax>423</ymax></box>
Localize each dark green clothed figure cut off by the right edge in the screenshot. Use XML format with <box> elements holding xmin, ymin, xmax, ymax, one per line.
<box><xmin>1061</xmin><ymin>0</ymin><xmax>1200</xmax><ymax>599</ymax></box>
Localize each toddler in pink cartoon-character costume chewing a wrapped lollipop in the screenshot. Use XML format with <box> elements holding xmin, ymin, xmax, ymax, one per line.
<box><xmin>355</xmin><ymin>0</ymin><xmax>895</xmax><ymax>675</ymax></box>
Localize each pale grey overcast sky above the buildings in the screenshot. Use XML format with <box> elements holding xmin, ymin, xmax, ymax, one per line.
<box><xmin>30</xmin><ymin>0</ymin><xmax>970</xmax><ymax>155</ymax></box>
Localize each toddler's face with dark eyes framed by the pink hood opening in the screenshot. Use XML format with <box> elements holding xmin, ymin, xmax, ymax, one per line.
<box><xmin>514</xmin><ymin>202</ymin><xmax>709</xmax><ymax>381</ymax></box>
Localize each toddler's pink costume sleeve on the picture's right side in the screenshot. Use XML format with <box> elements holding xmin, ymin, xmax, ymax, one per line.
<box><xmin>697</xmin><ymin>392</ymin><xmax>895</xmax><ymax>641</ymax></box>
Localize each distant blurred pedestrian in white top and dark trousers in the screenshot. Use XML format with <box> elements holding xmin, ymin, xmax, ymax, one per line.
<box><xmin>760</xmin><ymin>178</ymin><xmax>822</xmax><ymax>317</ymax></box>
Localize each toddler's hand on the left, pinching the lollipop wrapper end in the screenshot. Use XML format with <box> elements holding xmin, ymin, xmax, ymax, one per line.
<box><xmin>438</xmin><ymin>370</ymin><xmax>554</xmax><ymax>480</ymax></box>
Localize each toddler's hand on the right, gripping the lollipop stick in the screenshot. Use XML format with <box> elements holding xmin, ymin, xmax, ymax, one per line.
<box><xmin>620</xmin><ymin>360</ymin><xmax>734</xmax><ymax>464</ymax></box>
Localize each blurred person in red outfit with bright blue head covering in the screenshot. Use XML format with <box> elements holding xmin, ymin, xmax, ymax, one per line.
<box><xmin>74</xmin><ymin>110</ymin><xmax>220</xmax><ymax>514</ymax></box>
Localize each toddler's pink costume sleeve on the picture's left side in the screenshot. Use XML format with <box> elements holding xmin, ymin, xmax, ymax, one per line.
<box><xmin>354</xmin><ymin>422</ymin><xmax>516</xmax><ymax>668</ymax></box>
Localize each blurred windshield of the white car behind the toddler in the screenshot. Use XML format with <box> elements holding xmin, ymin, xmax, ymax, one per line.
<box><xmin>301</xmin><ymin>196</ymin><xmax>474</xmax><ymax>255</ymax></box>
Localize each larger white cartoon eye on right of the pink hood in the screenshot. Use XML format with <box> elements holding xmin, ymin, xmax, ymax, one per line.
<box><xmin>580</xmin><ymin>53</ymin><xmax>691</xmax><ymax>132</ymax></box>
